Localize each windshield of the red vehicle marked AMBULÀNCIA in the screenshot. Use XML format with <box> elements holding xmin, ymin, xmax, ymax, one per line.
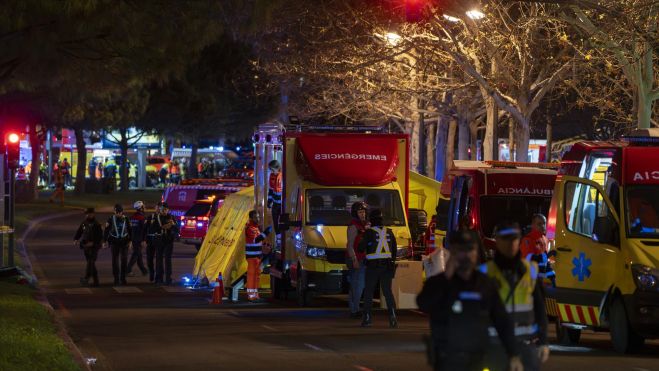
<box><xmin>480</xmin><ymin>196</ymin><xmax>551</xmax><ymax>237</ymax></box>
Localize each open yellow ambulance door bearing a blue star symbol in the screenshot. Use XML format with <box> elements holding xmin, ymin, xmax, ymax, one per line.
<box><xmin>553</xmin><ymin>176</ymin><xmax>620</xmax><ymax>325</ymax></box>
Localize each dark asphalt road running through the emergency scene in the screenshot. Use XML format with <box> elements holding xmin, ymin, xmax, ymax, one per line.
<box><xmin>26</xmin><ymin>215</ymin><xmax>659</xmax><ymax>371</ymax></box>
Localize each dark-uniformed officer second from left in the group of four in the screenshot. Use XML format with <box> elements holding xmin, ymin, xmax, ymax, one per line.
<box><xmin>104</xmin><ymin>204</ymin><xmax>132</xmax><ymax>286</ymax></box>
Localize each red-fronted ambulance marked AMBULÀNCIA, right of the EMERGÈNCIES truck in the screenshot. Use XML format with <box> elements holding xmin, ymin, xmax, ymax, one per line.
<box><xmin>436</xmin><ymin>160</ymin><xmax>558</xmax><ymax>249</ymax></box>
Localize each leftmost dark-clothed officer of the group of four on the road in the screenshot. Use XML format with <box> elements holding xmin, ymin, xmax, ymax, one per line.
<box><xmin>73</xmin><ymin>208</ymin><xmax>103</xmax><ymax>287</ymax></box>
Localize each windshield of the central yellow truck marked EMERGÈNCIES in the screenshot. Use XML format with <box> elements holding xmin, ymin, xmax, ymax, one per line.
<box><xmin>306</xmin><ymin>188</ymin><xmax>405</xmax><ymax>226</ymax></box>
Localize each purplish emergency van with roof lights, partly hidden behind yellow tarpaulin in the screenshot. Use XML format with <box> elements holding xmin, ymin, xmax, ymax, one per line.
<box><xmin>162</xmin><ymin>178</ymin><xmax>251</xmax><ymax>219</ymax></box>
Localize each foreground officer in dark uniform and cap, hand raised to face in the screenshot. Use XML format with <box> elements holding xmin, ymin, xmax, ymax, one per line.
<box><xmin>416</xmin><ymin>231</ymin><xmax>522</xmax><ymax>371</ymax></box>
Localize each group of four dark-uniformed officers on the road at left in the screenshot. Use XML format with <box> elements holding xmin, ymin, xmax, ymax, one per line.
<box><xmin>73</xmin><ymin>201</ymin><xmax>179</xmax><ymax>287</ymax></box>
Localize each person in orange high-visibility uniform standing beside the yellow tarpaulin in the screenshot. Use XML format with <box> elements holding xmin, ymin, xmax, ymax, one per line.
<box><xmin>245</xmin><ymin>210</ymin><xmax>272</xmax><ymax>301</ymax></box>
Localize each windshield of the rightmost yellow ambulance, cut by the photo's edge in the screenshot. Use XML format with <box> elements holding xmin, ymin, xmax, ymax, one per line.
<box><xmin>626</xmin><ymin>185</ymin><xmax>659</xmax><ymax>238</ymax></box>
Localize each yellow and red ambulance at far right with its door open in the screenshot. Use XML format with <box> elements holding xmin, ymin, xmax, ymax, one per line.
<box><xmin>547</xmin><ymin>132</ymin><xmax>659</xmax><ymax>352</ymax></box>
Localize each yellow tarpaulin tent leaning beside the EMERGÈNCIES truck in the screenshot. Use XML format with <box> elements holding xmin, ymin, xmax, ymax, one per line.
<box><xmin>193</xmin><ymin>187</ymin><xmax>254</xmax><ymax>286</ymax></box>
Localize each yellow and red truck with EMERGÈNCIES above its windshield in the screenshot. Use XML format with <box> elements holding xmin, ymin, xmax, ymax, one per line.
<box><xmin>254</xmin><ymin>124</ymin><xmax>411</xmax><ymax>305</ymax></box>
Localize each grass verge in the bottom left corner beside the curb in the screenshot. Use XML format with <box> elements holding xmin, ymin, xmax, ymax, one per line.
<box><xmin>0</xmin><ymin>279</ymin><xmax>80</xmax><ymax>371</ymax></box>
